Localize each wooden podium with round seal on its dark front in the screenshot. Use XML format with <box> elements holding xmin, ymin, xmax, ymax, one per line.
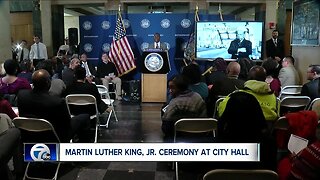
<box><xmin>141</xmin><ymin>49</ymin><xmax>170</xmax><ymax>102</ymax></box>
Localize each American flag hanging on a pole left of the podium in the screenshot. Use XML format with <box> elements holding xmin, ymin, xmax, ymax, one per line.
<box><xmin>109</xmin><ymin>12</ymin><xmax>136</xmax><ymax>76</ymax></box>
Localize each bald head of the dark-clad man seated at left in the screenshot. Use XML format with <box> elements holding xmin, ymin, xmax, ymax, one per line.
<box><xmin>32</xmin><ymin>69</ymin><xmax>51</xmax><ymax>92</ymax></box>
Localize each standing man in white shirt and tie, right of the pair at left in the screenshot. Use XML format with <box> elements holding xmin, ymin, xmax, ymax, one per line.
<box><xmin>29</xmin><ymin>35</ymin><xmax>48</xmax><ymax>67</ymax></box>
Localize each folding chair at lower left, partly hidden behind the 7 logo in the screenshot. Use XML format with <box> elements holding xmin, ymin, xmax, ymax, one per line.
<box><xmin>13</xmin><ymin>117</ymin><xmax>61</xmax><ymax>179</ymax></box>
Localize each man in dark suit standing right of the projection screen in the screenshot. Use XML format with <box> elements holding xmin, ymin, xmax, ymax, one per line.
<box><xmin>266</xmin><ymin>30</ymin><xmax>284</xmax><ymax>60</ymax></box>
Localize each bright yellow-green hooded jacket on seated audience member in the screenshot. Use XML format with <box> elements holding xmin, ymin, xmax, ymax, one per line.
<box><xmin>218</xmin><ymin>80</ymin><xmax>280</xmax><ymax>121</ymax></box>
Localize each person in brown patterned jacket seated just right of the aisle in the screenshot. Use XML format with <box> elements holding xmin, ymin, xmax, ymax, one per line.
<box><xmin>161</xmin><ymin>75</ymin><xmax>207</xmax><ymax>141</ymax></box>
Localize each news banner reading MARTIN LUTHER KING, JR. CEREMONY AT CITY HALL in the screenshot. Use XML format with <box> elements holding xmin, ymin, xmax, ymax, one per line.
<box><xmin>24</xmin><ymin>143</ymin><xmax>260</xmax><ymax>162</ymax></box>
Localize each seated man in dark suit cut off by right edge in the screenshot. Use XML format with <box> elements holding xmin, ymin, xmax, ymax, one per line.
<box><xmin>301</xmin><ymin>65</ymin><xmax>320</xmax><ymax>101</ymax></box>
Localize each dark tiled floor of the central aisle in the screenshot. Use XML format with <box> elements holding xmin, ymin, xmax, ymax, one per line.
<box><xmin>59</xmin><ymin>102</ymin><xmax>175</xmax><ymax>180</ymax></box>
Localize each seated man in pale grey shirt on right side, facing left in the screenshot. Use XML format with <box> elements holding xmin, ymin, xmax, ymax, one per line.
<box><xmin>278</xmin><ymin>56</ymin><xmax>300</xmax><ymax>87</ymax></box>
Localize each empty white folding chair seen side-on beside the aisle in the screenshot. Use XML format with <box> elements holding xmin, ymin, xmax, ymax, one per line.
<box><xmin>96</xmin><ymin>85</ymin><xmax>118</xmax><ymax>128</ymax></box>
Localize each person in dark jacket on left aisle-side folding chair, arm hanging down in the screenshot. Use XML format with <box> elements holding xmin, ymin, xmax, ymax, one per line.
<box><xmin>66</xmin><ymin>66</ymin><xmax>108</xmax><ymax>113</ymax></box>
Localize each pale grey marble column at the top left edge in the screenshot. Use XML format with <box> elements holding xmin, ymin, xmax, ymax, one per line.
<box><xmin>0</xmin><ymin>1</ymin><xmax>12</xmax><ymax>63</ymax></box>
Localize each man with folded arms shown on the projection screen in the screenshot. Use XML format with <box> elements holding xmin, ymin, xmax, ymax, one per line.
<box><xmin>228</xmin><ymin>28</ymin><xmax>252</xmax><ymax>59</ymax></box>
